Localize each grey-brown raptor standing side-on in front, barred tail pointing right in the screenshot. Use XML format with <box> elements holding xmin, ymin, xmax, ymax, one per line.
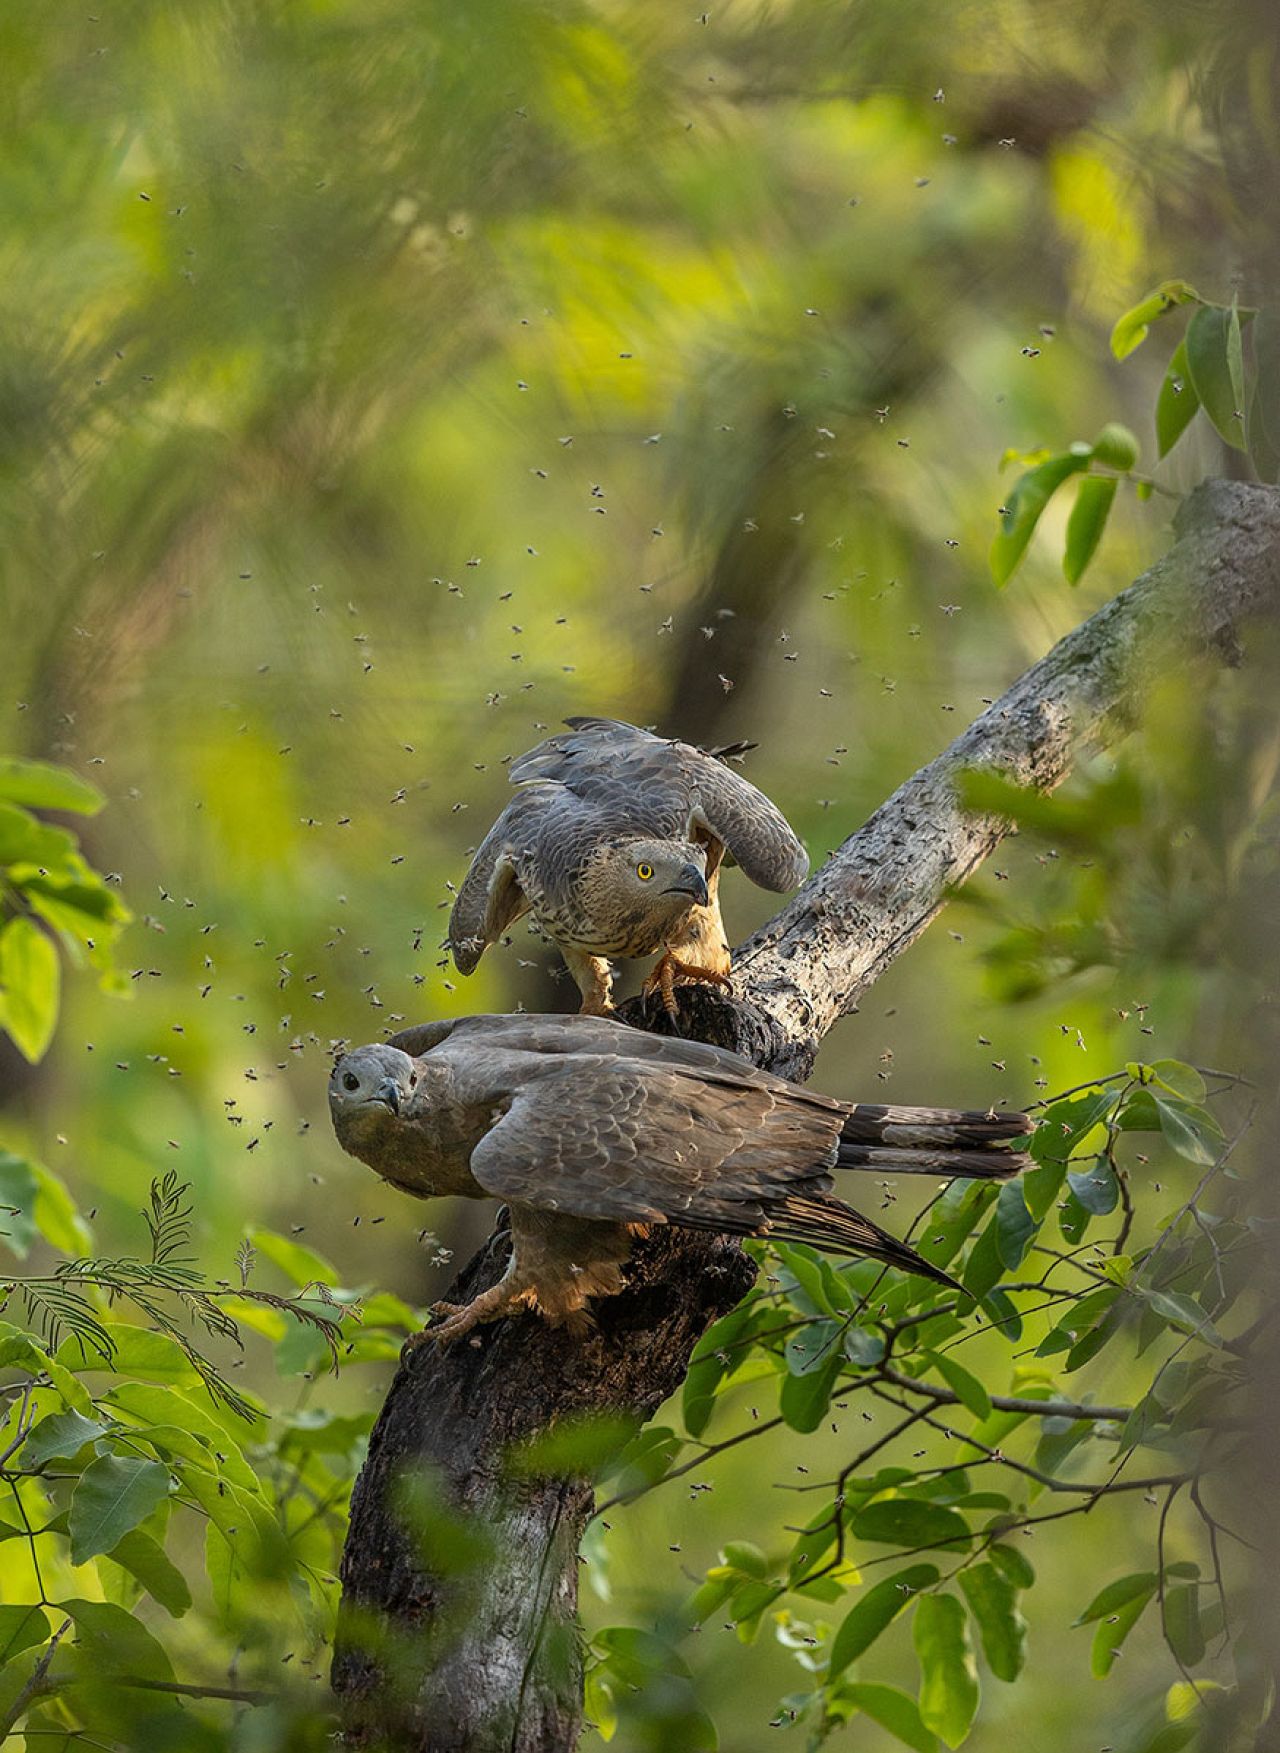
<box><xmin>330</xmin><ymin>1015</ymin><xmax>1033</xmax><ymax>1341</ymax></box>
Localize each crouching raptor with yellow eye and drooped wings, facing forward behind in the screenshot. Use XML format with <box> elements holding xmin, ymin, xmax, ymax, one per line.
<box><xmin>449</xmin><ymin>719</ymin><xmax>808</xmax><ymax>1017</ymax></box>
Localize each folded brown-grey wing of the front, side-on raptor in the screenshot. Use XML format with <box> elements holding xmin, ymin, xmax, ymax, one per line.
<box><xmin>472</xmin><ymin>1055</ymin><xmax>840</xmax><ymax>1234</ymax></box>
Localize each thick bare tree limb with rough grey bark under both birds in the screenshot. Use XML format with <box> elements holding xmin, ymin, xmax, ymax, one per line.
<box><xmin>333</xmin><ymin>482</ymin><xmax>1280</xmax><ymax>1753</ymax></box>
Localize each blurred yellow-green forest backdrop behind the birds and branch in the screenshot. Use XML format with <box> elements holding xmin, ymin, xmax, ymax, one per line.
<box><xmin>0</xmin><ymin>0</ymin><xmax>1280</xmax><ymax>1753</ymax></box>
